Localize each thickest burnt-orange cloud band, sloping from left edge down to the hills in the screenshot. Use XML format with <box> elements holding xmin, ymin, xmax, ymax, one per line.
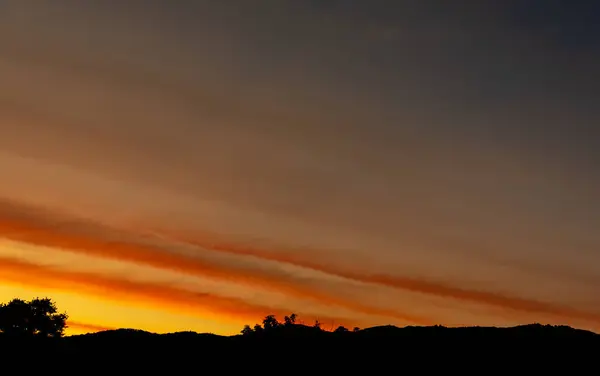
<box><xmin>0</xmin><ymin>201</ymin><xmax>433</xmax><ymax>324</ymax></box>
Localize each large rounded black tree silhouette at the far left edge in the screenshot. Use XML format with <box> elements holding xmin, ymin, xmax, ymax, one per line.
<box><xmin>0</xmin><ymin>298</ymin><xmax>68</xmax><ymax>338</ymax></box>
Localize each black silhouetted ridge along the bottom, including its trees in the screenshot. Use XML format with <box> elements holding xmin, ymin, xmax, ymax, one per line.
<box><xmin>0</xmin><ymin>298</ymin><xmax>600</xmax><ymax>374</ymax></box>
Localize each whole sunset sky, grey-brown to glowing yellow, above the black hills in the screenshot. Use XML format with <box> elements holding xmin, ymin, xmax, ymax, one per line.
<box><xmin>0</xmin><ymin>0</ymin><xmax>600</xmax><ymax>334</ymax></box>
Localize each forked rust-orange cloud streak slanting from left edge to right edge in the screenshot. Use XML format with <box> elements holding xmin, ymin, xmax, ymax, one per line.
<box><xmin>0</xmin><ymin>197</ymin><xmax>600</xmax><ymax>325</ymax></box>
